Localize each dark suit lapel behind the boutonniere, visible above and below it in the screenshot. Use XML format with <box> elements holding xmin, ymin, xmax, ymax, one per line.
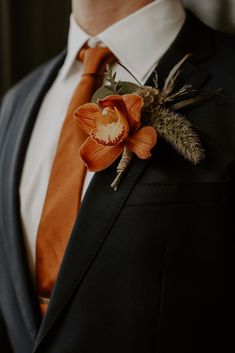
<box><xmin>34</xmin><ymin>14</ymin><xmax>215</xmax><ymax>351</ymax></box>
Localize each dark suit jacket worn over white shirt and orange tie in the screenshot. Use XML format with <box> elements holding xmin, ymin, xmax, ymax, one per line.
<box><xmin>0</xmin><ymin>14</ymin><xmax>235</xmax><ymax>353</ymax></box>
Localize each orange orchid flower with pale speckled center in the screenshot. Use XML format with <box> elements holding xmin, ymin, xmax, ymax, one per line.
<box><xmin>74</xmin><ymin>94</ymin><xmax>157</xmax><ymax>172</ymax></box>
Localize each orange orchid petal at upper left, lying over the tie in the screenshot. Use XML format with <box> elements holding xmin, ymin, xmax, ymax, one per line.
<box><xmin>74</xmin><ymin>103</ymin><xmax>98</xmax><ymax>135</ymax></box>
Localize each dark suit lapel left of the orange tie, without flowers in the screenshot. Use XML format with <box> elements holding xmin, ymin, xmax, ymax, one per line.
<box><xmin>0</xmin><ymin>53</ymin><xmax>64</xmax><ymax>341</ymax></box>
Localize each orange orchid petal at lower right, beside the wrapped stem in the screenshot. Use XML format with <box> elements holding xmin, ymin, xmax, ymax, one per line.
<box><xmin>126</xmin><ymin>126</ymin><xmax>157</xmax><ymax>159</ymax></box>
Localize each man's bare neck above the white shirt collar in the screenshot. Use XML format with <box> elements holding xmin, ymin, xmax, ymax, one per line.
<box><xmin>72</xmin><ymin>0</ymin><xmax>153</xmax><ymax>36</ymax></box>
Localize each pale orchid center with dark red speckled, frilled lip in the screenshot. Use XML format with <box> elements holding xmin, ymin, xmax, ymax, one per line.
<box><xmin>91</xmin><ymin>107</ymin><xmax>129</xmax><ymax>146</ymax></box>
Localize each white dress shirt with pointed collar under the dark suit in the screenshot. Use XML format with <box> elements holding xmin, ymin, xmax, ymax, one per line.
<box><xmin>20</xmin><ymin>0</ymin><xmax>185</xmax><ymax>277</ymax></box>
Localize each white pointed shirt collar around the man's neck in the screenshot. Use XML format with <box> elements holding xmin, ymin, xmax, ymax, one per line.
<box><xmin>61</xmin><ymin>0</ymin><xmax>186</xmax><ymax>82</ymax></box>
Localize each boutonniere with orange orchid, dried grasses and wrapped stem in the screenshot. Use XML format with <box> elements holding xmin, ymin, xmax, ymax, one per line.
<box><xmin>74</xmin><ymin>54</ymin><xmax>217</xmax><ymax>190</ymax></box>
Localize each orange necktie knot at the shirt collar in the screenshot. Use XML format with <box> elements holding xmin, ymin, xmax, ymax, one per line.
<box><xmin>78</xmin><ymin>46</ymin><xmax>115</xmax><ymax>76</ymax></box>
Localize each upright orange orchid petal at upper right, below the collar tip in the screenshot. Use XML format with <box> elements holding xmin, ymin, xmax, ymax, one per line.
<box><xmin>122</xmin><ymin>94</ymin><xmax>144</xmax><ymax>131</ymax></box>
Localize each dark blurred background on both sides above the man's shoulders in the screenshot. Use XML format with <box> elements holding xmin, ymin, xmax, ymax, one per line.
<box><xmin>0</xmin><ymin>0</ymin><xmax>235</xmax><ymax>97</ymax></box>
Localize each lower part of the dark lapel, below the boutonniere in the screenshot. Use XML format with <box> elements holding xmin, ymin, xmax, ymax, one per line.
<box><xmin>35</xmin><ymin>153</ymin><xmax>151</xmax><ymax>348</ymax></box>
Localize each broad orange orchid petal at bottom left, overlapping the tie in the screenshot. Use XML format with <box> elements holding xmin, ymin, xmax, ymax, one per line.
<box><xmin>80</xmin><ymin>137</ymin><xmax>124</xmax><ymax>172</ymax></box>
